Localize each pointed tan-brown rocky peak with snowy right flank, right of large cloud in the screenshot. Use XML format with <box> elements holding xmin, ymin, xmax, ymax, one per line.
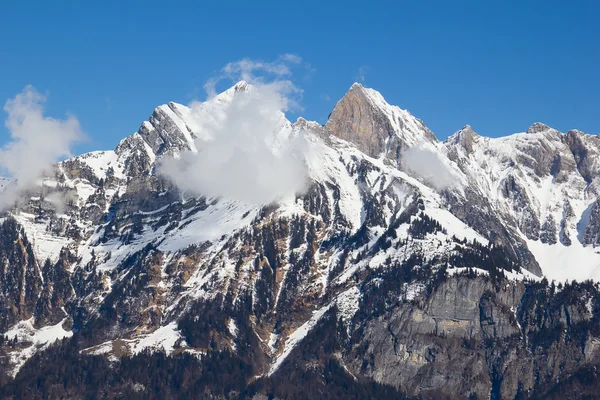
<box><xmin>325</xmin><ymin>83</ymin><xmax>437</xmax><ymax>161</ymax></box>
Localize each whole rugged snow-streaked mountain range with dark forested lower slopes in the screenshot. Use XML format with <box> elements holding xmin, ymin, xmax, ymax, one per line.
<box><xmin>0</xmin><ymin>82</ymin><xmax>600</xmax><ymax>399</ymax></box>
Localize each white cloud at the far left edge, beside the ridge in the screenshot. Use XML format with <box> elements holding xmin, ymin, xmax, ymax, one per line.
<box><xmin>0</xmin><ymin>86</ymin><xmax>84</xmax><ymax>208</ymax></box>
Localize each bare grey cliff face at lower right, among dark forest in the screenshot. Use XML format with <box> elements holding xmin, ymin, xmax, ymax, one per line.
<box><xmin>344</xmin><ymin>276</ymin><xmax>596</xmax><ymax>399</ymax></box>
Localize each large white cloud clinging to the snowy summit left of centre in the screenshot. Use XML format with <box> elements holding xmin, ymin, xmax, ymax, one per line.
<box><xmin>159</xmin><ymin>55</ymin><xmax>307</xmax><ymax>204</ymax></box>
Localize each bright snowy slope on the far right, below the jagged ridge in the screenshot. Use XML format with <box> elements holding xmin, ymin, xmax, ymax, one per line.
<box><xmin>445</xmin><ymin>123</ymin><xmax>600</xmax><ymax>281</ymax></box>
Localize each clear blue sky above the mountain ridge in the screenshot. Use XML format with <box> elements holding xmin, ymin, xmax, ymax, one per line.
<box><xmin>0</xmin><ymin>0</ymin><xmax>600</xmax><ymax>151</ymax></box>
